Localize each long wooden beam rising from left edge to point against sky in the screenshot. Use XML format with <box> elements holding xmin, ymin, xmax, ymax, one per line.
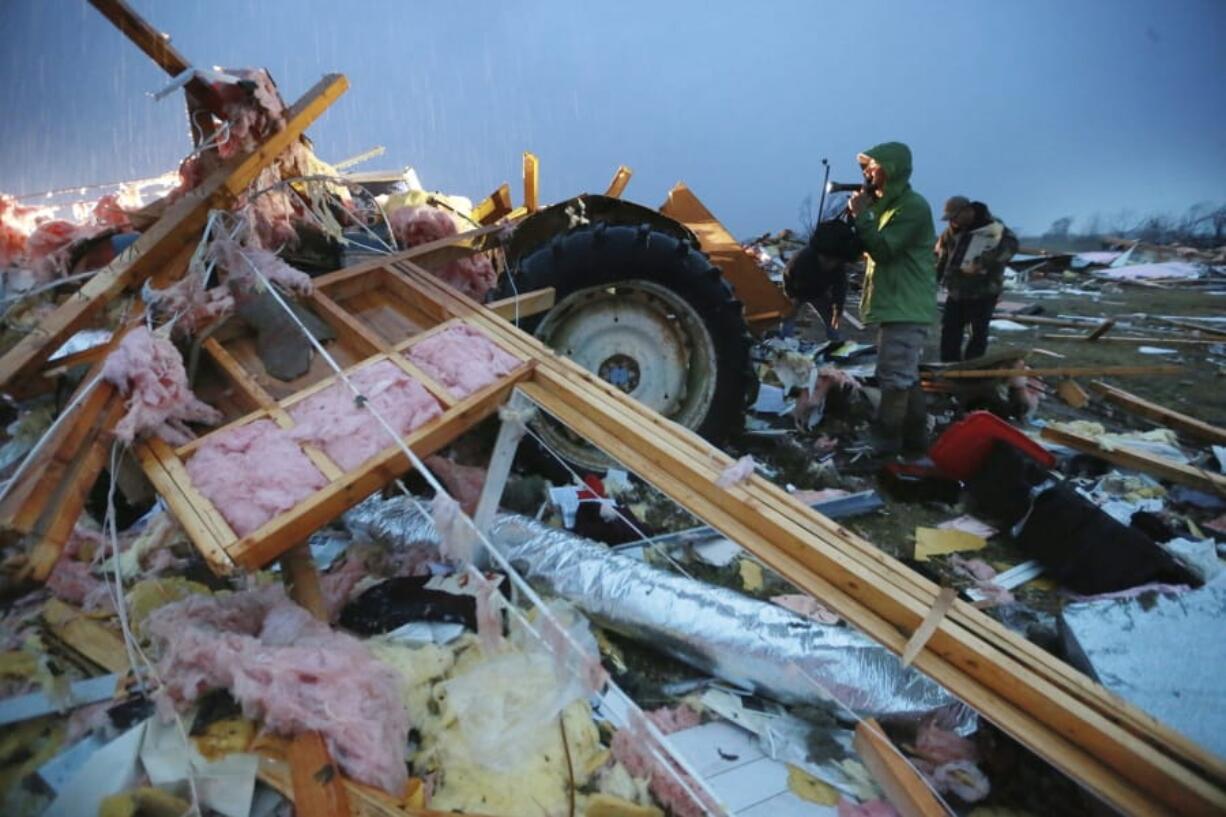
<box><xmin>0</xmin><ymin>74</ymin><xmax>348</xmax><ymax>389</ymax></box>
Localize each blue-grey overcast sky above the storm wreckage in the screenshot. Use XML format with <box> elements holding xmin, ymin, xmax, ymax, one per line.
<box><xmin>0</xmin><ymin>0</ymin><xmax>1226</xmax><ymax>237</ymax></box>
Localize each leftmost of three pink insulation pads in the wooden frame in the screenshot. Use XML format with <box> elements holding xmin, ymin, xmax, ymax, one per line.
<box><xmin>188</xmin><ymin>420</ymin><xmax>327</xmax><ymax>536</ymax></box>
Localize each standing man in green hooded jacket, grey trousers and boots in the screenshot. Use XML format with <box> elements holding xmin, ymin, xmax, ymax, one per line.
<box><xmin>847</xmin><ymin>142</ymin><xmax>937</xmax><ymax>454</ymax></box>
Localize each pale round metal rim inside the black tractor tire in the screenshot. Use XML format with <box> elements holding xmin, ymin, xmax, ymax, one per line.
<box><xmin>536</xmin><ymin>280</ymin><xmax>716</xmax><ymax>469</ymax></box>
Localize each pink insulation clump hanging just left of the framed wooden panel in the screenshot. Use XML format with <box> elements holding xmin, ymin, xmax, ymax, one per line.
<box><xmin>102</xmin><ymin>326</ymin><xmax>222</xmax><ymax>445</ymax></box>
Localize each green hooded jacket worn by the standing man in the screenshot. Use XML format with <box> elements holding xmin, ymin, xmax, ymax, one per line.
<box><xmin>856</xmin><ymin>142</ymin><xmax>937</xmax><ymax>324</ymax></box>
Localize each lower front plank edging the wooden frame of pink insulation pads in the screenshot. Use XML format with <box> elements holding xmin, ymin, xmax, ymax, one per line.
<box><xmin>226</xmin><ymin>366</ymin><xmax>531</xmax><ymax>569</ymax></box>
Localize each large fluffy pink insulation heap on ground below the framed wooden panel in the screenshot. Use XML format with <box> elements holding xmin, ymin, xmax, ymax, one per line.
<box><xmin>146</xmin><ymin>585</ymin><xmax>408</xmax><ymax>795</ymax></box>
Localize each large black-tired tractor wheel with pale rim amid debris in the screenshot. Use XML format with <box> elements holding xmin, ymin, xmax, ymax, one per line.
<box><xmin>499</xmin><ymin>222</ymin><xmax>758</xmax><ymax>470</ymax></box>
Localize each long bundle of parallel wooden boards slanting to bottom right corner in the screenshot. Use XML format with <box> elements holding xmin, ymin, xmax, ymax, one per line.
<box><xmin>384</xmin><ymin>258</ymin><xmax>1226</xmax><ymax>813</ymax></box>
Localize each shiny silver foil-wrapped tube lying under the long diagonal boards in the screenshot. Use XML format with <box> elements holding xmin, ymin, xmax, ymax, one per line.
<box><xmin>345</xmin><ymin>490</ymin><xmax>975</xmax><ymax>731</ymax></box>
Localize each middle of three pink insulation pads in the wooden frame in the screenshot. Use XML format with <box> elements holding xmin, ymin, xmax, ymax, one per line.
<box><xmin>289</xmin><ymin>361</ymin><xmax>443</xmax><ymax>471</ymax></box>
